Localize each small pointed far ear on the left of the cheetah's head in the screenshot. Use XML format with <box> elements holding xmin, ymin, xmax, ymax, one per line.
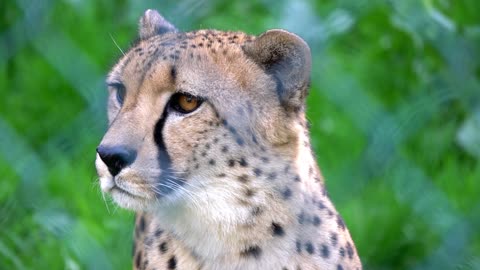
<box><xmin>139</xmin><ymin>9</ymin><xmax>178</xmax><ymax>40</ymax></box>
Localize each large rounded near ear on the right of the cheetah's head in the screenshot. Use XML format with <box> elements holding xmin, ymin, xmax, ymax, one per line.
<box><xmin>243</xmin><ymin>29</ymin><xmax>312</xmax><ymax>111</ymax></box>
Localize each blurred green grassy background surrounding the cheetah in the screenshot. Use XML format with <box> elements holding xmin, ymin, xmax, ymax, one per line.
<box><xmin>0</xmin><ymin>0</ymin><xmax>480</xmax><ymax>270</ymax></box>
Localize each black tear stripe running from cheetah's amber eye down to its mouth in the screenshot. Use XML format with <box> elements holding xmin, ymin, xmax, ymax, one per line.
<box><xmin>153</xmin><ymin>104</ymin><xmax>183</xmax><ymax>197</ymax></box>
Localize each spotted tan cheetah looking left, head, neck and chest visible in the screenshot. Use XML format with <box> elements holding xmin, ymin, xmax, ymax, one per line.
<box><xmin>95</xmin><ymin>10</ymin><xmax>362</xmax><ymax>270</ymax></box>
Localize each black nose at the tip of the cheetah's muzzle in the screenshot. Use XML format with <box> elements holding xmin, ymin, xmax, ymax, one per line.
<box><xmin>97</xmin><ymin>145</ymin><xmax>137</xmax><ymax>176</ymax></box>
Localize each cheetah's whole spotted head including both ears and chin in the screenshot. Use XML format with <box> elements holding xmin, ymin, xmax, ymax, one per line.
<box><xmin>95</xmin><ymin>10</ymin><xmax>310</xmax><ymax>210</ymax></box>
